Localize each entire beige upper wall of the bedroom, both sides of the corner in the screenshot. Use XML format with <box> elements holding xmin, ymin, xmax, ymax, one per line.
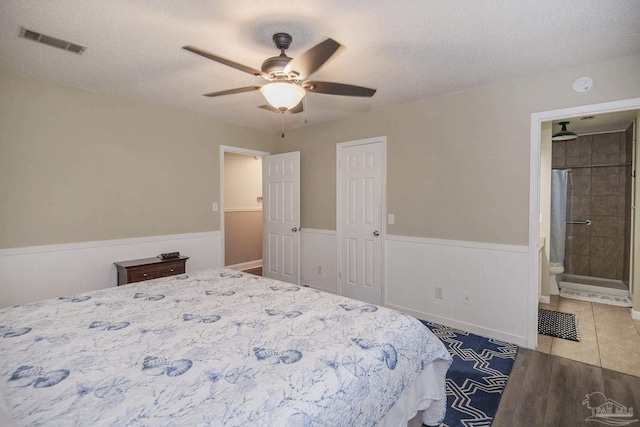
<box><xmin>0</xmin><ymin>55</ymin><xmax>640</xmax><ymax>248</ymax></box>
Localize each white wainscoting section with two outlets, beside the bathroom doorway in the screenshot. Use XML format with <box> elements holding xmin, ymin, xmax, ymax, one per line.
<box><xmin>385</xmin><ymin>236</ymin><xmax>529</xmax><ymax>346</ymax></box>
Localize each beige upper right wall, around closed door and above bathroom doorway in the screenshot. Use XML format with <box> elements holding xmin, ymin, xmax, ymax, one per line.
<box><xmin>273</xmin><ymin>55</ymin><xmax>640</xmax><ymax>245</ymax></box>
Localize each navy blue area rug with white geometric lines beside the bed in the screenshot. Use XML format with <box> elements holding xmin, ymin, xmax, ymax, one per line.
<box><xmin>421</xmin><ymin>320</ymin><xmax>518</xmax><ymax>427</ymax></box>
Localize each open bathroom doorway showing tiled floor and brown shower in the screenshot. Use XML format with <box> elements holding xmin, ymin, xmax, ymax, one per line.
<box><xmin>536</xmin><ymin>110</ymin><xmax>640</xmax><ymax>375</ymax></box>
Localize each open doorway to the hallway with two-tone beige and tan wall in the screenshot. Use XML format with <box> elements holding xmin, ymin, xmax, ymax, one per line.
<box><xmin>220</xmin><ymin>146</ymin><xmax>268</xmax><ymax>275</ymax></box>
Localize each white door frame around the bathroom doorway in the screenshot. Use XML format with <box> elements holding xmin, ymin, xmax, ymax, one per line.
<box><xmin>526</xmin><ymin>98</ymin><xmax>640</xmax><ymax>349</ymax></box>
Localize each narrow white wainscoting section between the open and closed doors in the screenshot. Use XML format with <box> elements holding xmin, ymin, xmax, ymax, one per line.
<box><xmin>300</xmin><ymin>228</ymin><xmax>338</xmax><ymax>294</ymax></box>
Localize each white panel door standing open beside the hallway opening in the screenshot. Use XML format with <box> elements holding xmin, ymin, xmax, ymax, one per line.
<box><xmin>262</xmin><ymin>151</ymin><xmax>300</xmax><ymax>284</ymax></box>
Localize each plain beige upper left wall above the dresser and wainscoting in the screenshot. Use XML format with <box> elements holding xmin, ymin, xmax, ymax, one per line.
<box><xmin>0</xmin><ymin>70</ymin><xmax>271</xmax><ymax>248</ymax></box>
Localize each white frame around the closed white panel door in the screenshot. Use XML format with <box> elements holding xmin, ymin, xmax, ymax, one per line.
<box><xmin>336</xmin><ymin>136</ymin><xmax>387</xmax><ymax>306</ymax></box>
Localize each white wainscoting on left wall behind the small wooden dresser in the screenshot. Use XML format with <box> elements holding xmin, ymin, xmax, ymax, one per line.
<box><xmin>0</xmin><ymin>231</ymin><xmax>222</xmax><ymax>308</ymax></box>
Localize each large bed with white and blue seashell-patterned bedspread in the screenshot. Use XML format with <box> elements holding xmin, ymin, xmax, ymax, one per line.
<box><xmin>0</xmin><ymin>269</ymin><xmax>451</xmax><ymax>427</ymax></box>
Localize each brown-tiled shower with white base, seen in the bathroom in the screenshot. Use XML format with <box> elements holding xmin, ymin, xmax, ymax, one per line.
<box><xmin>549</xmin><ymin>117</ymin><xmax>637</xmax><ymax>306</ymax></box>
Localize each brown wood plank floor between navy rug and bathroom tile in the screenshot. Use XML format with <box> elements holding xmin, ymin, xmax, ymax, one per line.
<box><xmin>492</xmin><ymin>348</ymin><xmax>640</xmax><ymax>427</ymax></box>
